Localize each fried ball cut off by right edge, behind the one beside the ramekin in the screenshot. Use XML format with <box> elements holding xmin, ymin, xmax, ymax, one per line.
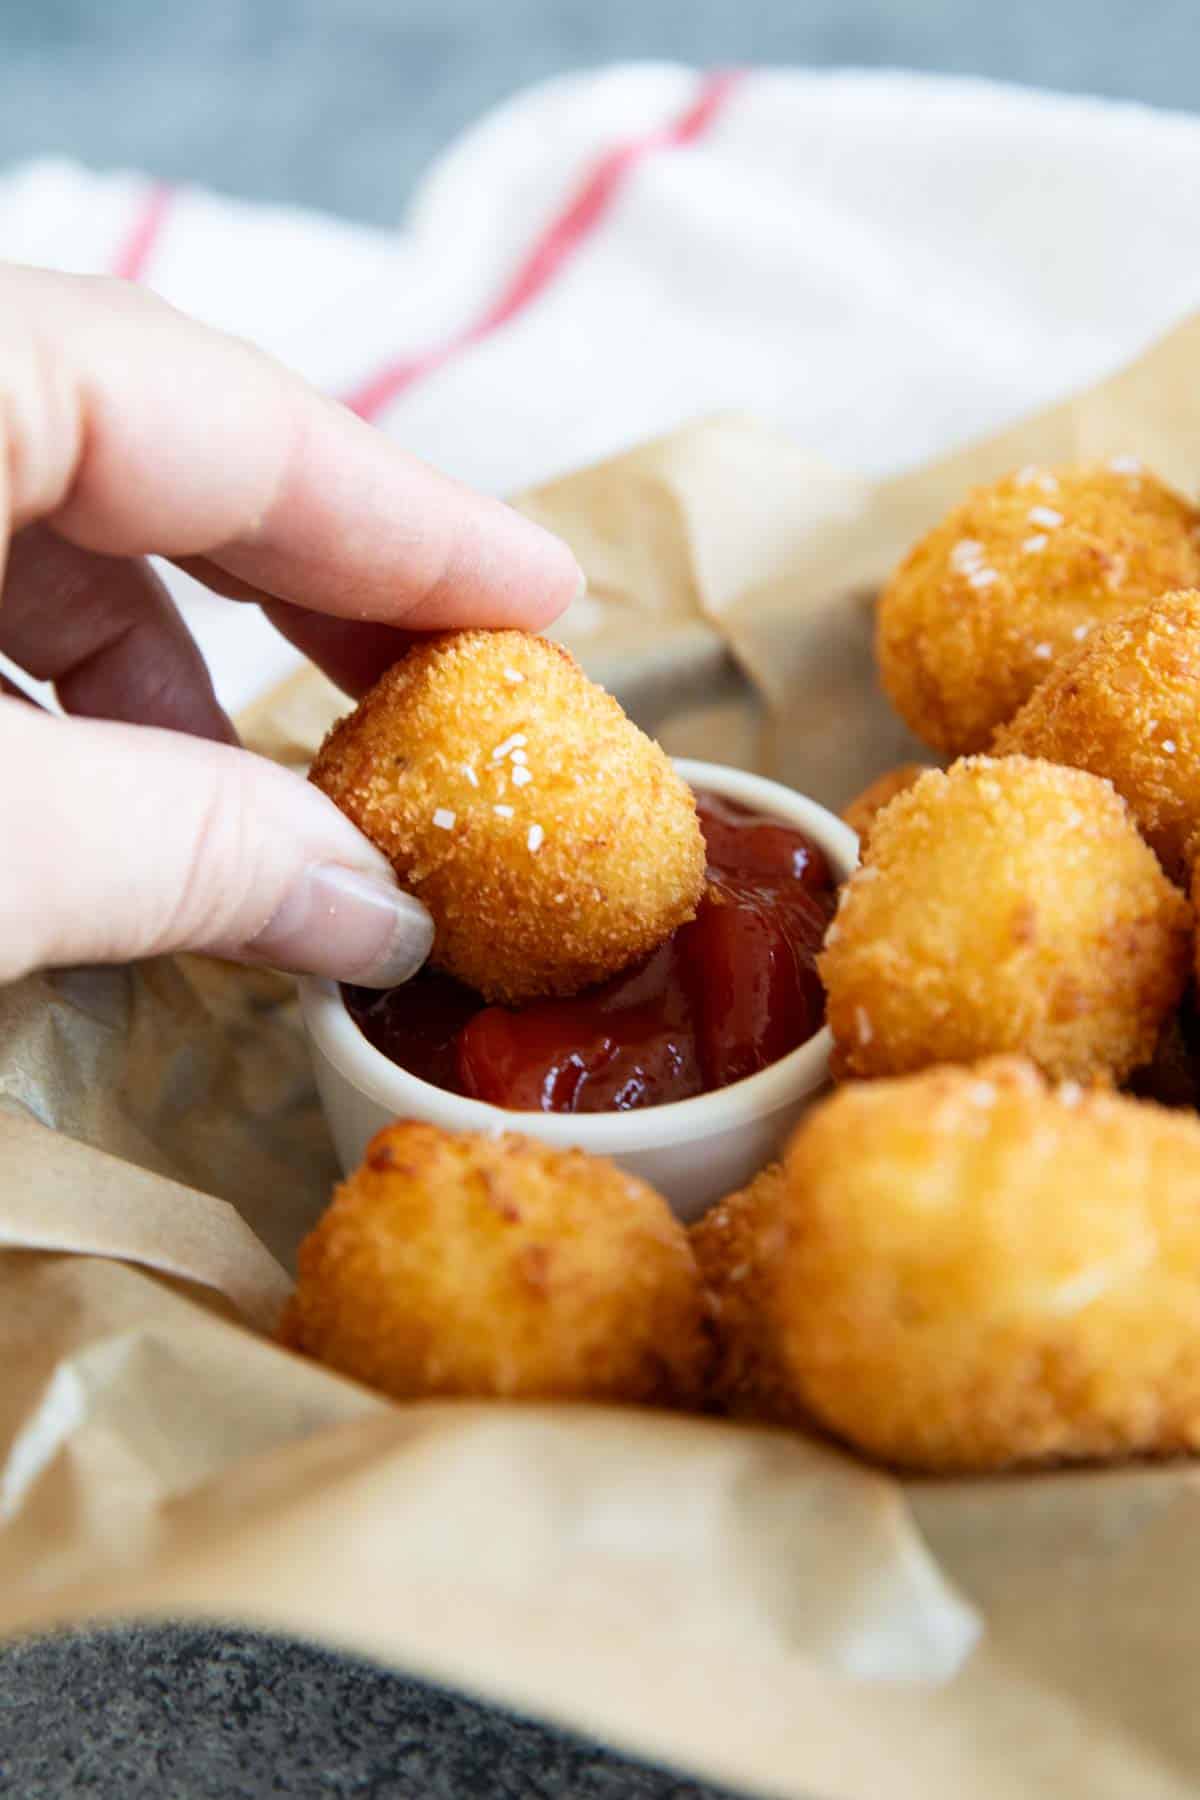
<box><xmin>995</xmin><ymin>589</ymin><xmax>1200</xmax><ymax>882</ymax></box>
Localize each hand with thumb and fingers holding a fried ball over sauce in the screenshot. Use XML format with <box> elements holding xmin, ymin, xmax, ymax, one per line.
<box><xmin>0</xmin><ymin>268</ymin><xmax>579</xmax><ymax>986</ymax></box>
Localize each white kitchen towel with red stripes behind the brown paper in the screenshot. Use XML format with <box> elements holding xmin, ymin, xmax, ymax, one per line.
<box><xmin>0</xmin><ymin>65</ymin><xmax>1200</xmax><ymax>707</ymax></box>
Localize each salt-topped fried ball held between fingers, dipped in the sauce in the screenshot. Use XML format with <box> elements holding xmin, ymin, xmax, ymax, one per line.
<box><xmin>311</xmin><ymin>632</ymin><xmax>705</xmax><ymax>1003</ymax></box>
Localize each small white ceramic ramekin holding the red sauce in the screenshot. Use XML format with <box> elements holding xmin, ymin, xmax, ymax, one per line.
<box><xmin>300</xmin><ymin>760</ymin><xmax>858</xmax><ymax>1220</ymax></box>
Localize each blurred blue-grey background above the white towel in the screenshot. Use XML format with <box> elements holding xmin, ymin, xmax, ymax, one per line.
<box><xmin>9</xmin><ymin>0</ymin><xmax>1200</xmax><ymax>223</ymax></box>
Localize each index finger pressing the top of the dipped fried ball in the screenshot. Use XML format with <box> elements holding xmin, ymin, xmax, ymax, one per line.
<box><xmin>0</xmin><ymin>268</ymin><xmax>581</xmax><ymax>628</ymax></box>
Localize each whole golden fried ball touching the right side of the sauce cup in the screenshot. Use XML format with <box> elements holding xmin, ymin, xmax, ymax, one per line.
<box><xmin>817</xmin><ymin>756</ymin><xmax>1191</xmax><ymax>1082</ymax></box>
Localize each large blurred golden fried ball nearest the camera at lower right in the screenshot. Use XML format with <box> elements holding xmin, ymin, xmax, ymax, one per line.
<box><xmin>768</xmin><ymin>1058</ymin><xmax>1200</xmax><ymax>1472</ymax></box>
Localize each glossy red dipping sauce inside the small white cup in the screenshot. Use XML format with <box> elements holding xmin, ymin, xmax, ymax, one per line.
<box><xmin>342</xmin><ymin>794</ymin><xmax>837</xmax><ymax>1112</ymax></box>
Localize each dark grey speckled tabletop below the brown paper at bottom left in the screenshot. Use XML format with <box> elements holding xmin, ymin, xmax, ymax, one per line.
<box><xmin>0</xmin><ymin>1629</ymin><xmax>744</xmax><ymax>1800</ymax></box>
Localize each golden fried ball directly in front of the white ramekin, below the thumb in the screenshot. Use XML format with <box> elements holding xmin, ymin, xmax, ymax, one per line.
<box><xmin>281</xmin><ymin>1123</ymin><xmax>707</xmax><ymax>1404</ymax></box>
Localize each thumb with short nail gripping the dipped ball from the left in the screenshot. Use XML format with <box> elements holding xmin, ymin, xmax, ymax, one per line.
<box><xmin>0</xmin><ymin>700</ymin><xmax>434</xmax><ymax>986</ymax></box>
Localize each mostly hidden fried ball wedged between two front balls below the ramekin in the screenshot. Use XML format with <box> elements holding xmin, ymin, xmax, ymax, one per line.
<box><xmin>689</xmin><ymin>1163</ymin><xmax>804</xmax><ymax>1426</ymax></box>
